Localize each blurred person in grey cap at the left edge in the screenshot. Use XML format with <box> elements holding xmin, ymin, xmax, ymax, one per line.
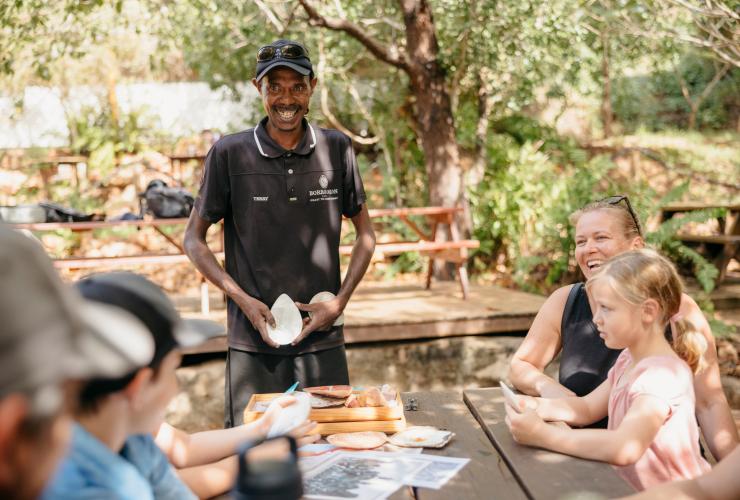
<box><xmin>0</xmin><ymin>223</ymin><xmax>154</xmax><ymax>499</ymax></box>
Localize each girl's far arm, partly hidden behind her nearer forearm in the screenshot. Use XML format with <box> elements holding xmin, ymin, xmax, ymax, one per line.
<box><xmin>528</xmin><ymin>380</ymin><xmax>611</xmax><ymax>427</ymax></box>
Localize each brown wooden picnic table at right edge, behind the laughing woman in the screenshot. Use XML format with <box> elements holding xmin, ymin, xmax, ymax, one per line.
<box><xmin>661</xmin><ymin>203</ymin><xmax>740</xmax><ymax>284</ymax></box>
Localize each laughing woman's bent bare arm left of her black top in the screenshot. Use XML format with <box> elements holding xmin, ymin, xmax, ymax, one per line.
<box><xmin>508</xmin><ymin>285</ymin><xmax>575</xmax><ymax>397</ymax></box>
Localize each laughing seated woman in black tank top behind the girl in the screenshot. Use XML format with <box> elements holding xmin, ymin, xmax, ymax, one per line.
<box><xmin>508</xmin><ymin>196</ymin><xmax>738</xmax><ymax>460</ymax></box>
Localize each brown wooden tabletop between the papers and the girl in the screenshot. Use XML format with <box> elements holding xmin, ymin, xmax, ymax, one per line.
<box><xmin>384</xmin><ymin>388</ymin><xmax>634</xmax><ymax>500</ymax></box>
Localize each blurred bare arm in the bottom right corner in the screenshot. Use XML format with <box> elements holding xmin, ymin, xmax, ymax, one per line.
<box><xmin>628</xmin><ymin>447</ymin><xmax>740</xmax><ymax>500</ymax></box>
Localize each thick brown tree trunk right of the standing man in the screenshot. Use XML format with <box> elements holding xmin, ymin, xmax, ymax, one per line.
<box><xmin>401</xmin><ymin>0</ymin><xmax>462</xmax><ymax>206</ymax></box>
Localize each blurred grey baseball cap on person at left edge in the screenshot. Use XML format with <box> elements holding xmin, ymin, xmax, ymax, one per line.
<box><xmin>0</xmin><ymin>223</ymin><xmax>154</xmax><ymax>397</ymax></box>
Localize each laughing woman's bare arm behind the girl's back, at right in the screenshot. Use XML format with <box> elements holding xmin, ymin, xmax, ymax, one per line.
<box><xmin>680</xmin><ymin>294</ymin><xmax>738</xmax><ymax>460</ymax></box>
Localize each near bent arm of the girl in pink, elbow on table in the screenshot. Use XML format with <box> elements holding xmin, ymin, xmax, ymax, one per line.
<box><xmin>506</xmin><ymin>395</ymin><xmax>670</xmax><ymax>465</ymax></box>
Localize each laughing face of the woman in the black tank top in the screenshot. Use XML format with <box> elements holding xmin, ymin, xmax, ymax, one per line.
<box><xmin>575</xmin><ymin>210</ymin><xmax>642</xmax><ymax>279</ymax></box>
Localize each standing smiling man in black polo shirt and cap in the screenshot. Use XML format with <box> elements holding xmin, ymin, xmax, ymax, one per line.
<box><xmin>185</xmin><ymin>40</ymin><xmax>375</xmax><ymax>427</ymax></box>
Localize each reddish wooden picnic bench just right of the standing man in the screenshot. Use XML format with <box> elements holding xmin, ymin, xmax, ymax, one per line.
<box><xmin>339</xmin><ymin>207</ymin><xmax>480</xmax><ymax>299</ymax></box>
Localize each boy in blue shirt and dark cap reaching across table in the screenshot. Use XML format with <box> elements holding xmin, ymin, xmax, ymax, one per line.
<box><xmin>43</xmin><ymin>272</ymin><xmax>316</xmax><ymax>500</ymax></box>
